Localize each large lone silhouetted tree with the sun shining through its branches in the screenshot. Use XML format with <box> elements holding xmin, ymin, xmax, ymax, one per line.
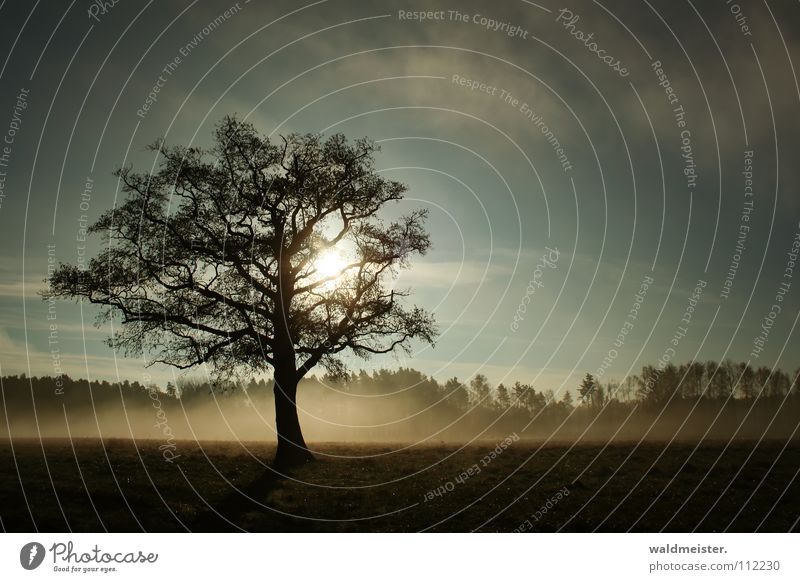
<box><xmin>50</xmin><ymin>117</ymin><xmax>436</xmax><ymax>467</ymax></box>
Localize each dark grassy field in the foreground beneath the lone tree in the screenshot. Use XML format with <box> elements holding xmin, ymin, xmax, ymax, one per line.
<box><xmin>0</xmin><ymin>440</ymin><xmax>800</xmax><ymax>532</ymax></box>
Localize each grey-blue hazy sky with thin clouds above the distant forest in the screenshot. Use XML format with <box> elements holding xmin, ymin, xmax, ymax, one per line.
<box><xmin>0</xmin><ymin>0</ymin><xmax>800</xmax><ymax>393</ymax></box>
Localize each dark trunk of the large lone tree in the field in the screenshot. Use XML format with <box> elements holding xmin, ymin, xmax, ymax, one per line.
<box><xmin>273</xmin><ymin>371</ymin><xmax>314</xmax><ymax>469</ymax></box>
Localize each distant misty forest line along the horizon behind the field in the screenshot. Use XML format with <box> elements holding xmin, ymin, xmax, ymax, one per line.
<box><xmin>0</xmin><ymin>362</ymin><xmax>800</xmax><ymax>442</ymax></box>
